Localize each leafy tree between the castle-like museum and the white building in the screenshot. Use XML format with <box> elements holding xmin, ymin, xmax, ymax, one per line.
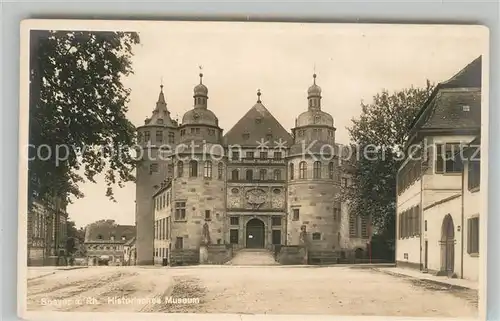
<box><xmin>342</xmin><ymin>81</ymin><xmax>434</xmax><ymax>250</ymax></box>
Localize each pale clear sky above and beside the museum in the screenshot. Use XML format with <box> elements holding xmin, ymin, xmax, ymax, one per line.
<box><xmin>61</xmin><ymin>22</ymin><xmax>487</xmax><ymax>227</ymax></box>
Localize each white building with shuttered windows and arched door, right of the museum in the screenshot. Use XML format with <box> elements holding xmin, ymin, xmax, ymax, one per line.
<box><xmin>396</xmin><ymin>57</ymin><xmax>481</xmax><ymax>280</ymax></box>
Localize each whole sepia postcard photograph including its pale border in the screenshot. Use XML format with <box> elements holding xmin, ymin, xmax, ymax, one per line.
<box><xmin>18</xmin><ymin>20</ymin><xmax>489</xmax><ymax>319</ymax></box>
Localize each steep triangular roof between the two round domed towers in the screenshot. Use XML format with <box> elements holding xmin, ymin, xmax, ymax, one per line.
<box><xmin>223</xmin><ymin>102</ymin><xmax>293</xmax><ymax>147</ymax></box>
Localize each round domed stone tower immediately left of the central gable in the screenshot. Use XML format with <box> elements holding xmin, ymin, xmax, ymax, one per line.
<box><xmin>171</xmin><ymin>73</ymin><xmax>226</xmax><ymax>250</ymax></box>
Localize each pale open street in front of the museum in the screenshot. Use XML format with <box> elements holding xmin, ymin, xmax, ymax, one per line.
<box><xmin>28</xmin><ymin>266</ymin><xmax>477</xmax><ymax>317</ymax></box>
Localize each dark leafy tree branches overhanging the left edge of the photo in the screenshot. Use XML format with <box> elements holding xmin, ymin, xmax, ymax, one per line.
<box><xmin>28</xmin><ymin>30</ymin><xmax>139</xmax><ymax>206</ymax></box>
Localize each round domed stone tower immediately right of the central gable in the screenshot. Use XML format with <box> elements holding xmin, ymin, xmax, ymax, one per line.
<box><xmin>287</xmin><ymin>74</ymin><xmax>341</xmax><ymax>251</ymax></box>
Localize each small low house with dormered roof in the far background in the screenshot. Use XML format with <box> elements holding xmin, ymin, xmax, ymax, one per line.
<box><xmin>85</xmin><ymin>220</ymin><xmax>135</xmax><ymax>265</ymax></box>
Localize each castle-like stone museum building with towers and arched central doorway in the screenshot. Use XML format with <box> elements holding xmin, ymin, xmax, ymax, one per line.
<box><xmin>136</xmin><ymin>74</ymin><xmax>369</xmax><ymax>264</ymax></box>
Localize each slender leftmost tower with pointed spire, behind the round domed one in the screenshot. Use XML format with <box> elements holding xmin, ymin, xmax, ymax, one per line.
<box><xmin>135</xmin><ymin>85</ymin><xmax>178</xmax><ymax>265</ymax></box>
